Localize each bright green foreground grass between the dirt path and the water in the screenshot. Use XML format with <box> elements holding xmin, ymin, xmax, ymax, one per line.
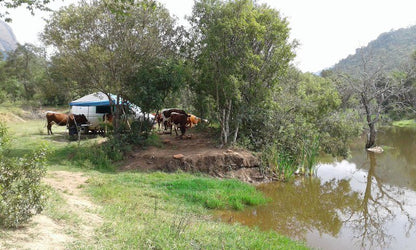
<box><xmin>84</xmin><ymin>172</ymin><xmax>305</xmax><ymax>249</ymax></box>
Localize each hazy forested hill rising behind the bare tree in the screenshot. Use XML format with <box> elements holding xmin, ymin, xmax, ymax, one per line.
<box><xmin>331</xmin><ymin>25</ymin><xmax>416</xmax><ymax>75</ymax></box>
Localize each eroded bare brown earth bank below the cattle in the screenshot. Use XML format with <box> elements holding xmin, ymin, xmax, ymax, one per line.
<box><xmin>119</xmin><ymin>129</ymin><xmax>270</xmax><ymax>183</ymax></box>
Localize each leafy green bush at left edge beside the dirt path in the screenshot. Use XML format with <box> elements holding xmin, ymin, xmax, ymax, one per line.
<box><xmin>0</xmin><ymin>122</ymin><xmax>46</xmax><ymax>228</ymax></box>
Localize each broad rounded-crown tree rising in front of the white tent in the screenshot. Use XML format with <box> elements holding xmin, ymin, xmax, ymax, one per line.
<box><xmin>43</xmin><ymin>0</ymin><xmax>182</xmax><ymax>132</ymax></box>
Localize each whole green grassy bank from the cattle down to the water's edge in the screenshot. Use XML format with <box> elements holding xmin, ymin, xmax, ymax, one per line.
<box><xmin>2</xmin><ymin>114</ymin><xmax>305</xmax><ymax>249</ymax></box>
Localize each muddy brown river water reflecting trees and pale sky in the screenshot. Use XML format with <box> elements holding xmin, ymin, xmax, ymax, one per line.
<box><xmin>220</xmin><ymin>128</ymin><xmax>416</xmax><ymax>249</ymax></box>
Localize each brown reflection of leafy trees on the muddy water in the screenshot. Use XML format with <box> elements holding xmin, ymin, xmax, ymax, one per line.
<box><xmin>218</xmin><ymin>178</ymin><xmax>360</xmax><ymax>240</ymax></box>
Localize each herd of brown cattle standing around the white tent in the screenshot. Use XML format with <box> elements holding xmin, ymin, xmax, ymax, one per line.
<box><xmin>46</xmin><ymin>108</ymin><xmax>208</xmax><ymax>138</ymax></box>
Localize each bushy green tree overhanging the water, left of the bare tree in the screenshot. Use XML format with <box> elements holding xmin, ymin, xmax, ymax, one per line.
<box><xmin>266</xmin><ymin>67</ymin><xmax>361</xmax><ymax>164</ymax></box>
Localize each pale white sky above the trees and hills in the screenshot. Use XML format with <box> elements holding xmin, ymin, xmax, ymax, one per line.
<box><xmin>5</xmin><ymin>0</ymin><xmax>416</xmax><ymax>72</ymax></box>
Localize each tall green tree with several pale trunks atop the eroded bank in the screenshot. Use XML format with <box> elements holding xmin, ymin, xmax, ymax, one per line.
<box><xmin>189</xmin><ymin>0</ymin><xmax>295</xmax><ymax>145</ymax></box>
